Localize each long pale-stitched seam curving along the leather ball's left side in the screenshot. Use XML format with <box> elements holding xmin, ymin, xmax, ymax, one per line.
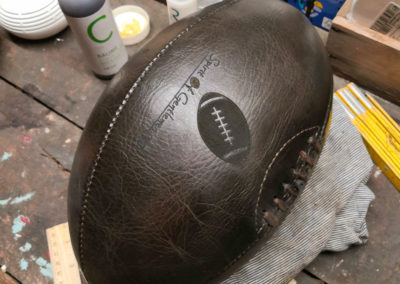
<box><xmin>78</xmin><ymin>0</ymin><xmax>239</xmax><ymax>276</ymax></box>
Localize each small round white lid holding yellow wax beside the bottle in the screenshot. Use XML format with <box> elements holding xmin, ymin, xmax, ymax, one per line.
<box><xmin>113</xmin><ymin>5</ymin><xmax>150</xmax><ymax>45</ymax></box>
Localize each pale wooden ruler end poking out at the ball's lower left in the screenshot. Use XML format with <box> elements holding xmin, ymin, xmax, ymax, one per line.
<box><xmin>46</xmin><ymin>223</ymin><xmax>81</xmax><ymax>284</ymax></box>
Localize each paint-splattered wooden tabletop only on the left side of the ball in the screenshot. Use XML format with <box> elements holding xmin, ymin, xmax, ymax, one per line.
<box><xmin>0</xmin><ymin>0</ymin><xmax>168</xmax><ymax>284</ymax></box>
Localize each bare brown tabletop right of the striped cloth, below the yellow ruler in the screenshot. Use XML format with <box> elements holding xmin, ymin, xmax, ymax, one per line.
<box><xmin>307</xmin><ymin>167</ymin><xmax>400</xmax><ymax>284</ymax></box>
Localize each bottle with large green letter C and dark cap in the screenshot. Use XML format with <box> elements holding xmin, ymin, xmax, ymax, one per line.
<box><xmin>58</xmin><ymin>0</ymin><xmax>128</xmax><ymax>79</ymax></box>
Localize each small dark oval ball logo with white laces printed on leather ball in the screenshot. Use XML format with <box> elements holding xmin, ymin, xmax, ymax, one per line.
<box><xmin>197</xmin><ymin>93</ymin><xmax>250</xmax><ymax>163</ymax></box>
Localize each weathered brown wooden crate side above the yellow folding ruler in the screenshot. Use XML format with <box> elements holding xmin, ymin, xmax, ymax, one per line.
<box><xmin>327</xmin><ymin>9</ymin><xmax>400</xmax><ymax>105</ymax></box>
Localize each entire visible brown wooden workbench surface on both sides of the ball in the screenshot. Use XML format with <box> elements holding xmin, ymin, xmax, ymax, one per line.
<box><xmin>0</xmin><ymin>0</ymin><xmax>400</xmax><ymax>284</ymax></box>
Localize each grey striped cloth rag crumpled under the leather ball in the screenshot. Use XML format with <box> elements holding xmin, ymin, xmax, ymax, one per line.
<box><xmin>222</xmin><ymin>98</ymin><xmax>375</xmax><ymax>284</ymax></box>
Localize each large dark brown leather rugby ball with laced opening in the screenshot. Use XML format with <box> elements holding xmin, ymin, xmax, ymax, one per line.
<box><xmin>68</xmin><ymin>0</ymin><xmax>332</xmax><ymax>283</ymax></box>
